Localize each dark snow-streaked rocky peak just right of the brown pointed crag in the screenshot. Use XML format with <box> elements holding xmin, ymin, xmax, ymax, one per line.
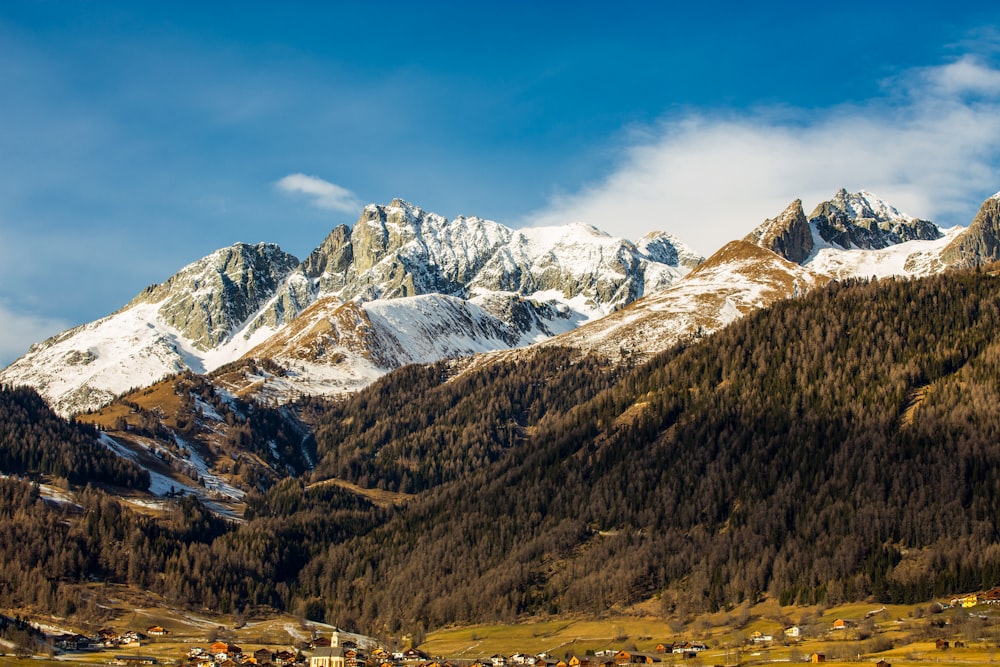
<box><xmin>809</xmin><ymin>188</ymin><xmax>941</xmax><ymax>250</ymax></box>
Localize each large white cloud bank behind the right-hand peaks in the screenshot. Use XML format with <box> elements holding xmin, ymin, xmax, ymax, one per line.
<box><xmin>525</xmin><ymin>57</ymin><xmax>1000</xmax><ymax>254</ymax></box>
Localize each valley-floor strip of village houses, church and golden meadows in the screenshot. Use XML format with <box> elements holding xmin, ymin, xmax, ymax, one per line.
<box><xmin>4</xmin><ymin>587</ymin><xmax>1000</xmax><ymax>667</ymax></box>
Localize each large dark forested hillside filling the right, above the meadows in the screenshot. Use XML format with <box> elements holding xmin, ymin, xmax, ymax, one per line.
<box><xmin>301</xmin><ymin>274</ymin><xmax>1000</xmax><ymax>625</ymax></box>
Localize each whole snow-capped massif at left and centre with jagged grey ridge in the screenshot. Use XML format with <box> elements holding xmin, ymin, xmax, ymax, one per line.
<box><xmin>0</xmin><ymin>199</ymin><xmax>701</xmax><ymax>414</ymax></box>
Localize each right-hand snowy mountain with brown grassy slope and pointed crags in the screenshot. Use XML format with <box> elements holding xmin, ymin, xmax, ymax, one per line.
<box><xmin>544</xmin><ymin>189</ymin><xmax>1000</xmax><ymax>360</ymax></box>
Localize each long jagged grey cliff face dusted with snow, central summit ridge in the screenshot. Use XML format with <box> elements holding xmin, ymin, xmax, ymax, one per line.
<box><xmin>247</xmin><ymin>199</ymin><xmax>703</xmax><ymax>333</ymax></box>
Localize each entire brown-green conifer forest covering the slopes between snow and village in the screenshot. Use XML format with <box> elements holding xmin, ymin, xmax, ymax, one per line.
<box><xmin>0</xmin><ymin>272</ymin><xmax>1000</xmax><ymax>632</ymax></box>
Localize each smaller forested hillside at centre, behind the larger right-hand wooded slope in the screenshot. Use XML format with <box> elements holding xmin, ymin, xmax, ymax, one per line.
<box><xmin>314</xmin><ymin>349</ymin><xmax>612</xmax><ymax>493</ymax></box>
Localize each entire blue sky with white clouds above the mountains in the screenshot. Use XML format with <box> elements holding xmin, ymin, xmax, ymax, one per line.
<box><xmin>0</xmin><ymin>0</ymin><xmax>1000</xmax><ymax>365</ymax></box>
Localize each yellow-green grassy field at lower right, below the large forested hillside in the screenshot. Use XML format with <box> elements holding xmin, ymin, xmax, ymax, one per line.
<box><xmin>421</xmin><ymin>603</ymin><xmax>1000</xmax><ymax>667</ymax></box>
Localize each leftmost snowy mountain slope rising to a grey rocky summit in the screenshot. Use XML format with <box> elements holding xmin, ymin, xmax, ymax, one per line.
<box><xmin>0</xmin><ymin>243</ymin><xmax>298</xmax><ymax>414</ymax></box>
